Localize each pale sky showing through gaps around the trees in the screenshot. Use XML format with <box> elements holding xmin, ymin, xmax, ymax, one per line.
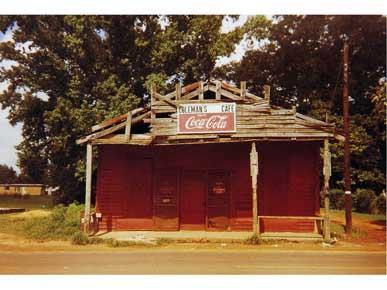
<box><xmin>0</xmin><ymin>15</ymin><xmax>255</xmax><ymax>172</ymax></box>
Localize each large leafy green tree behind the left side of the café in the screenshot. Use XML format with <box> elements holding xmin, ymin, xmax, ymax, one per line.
<box><xmin>0</xmin><ymin>15</ymin><xmax>247</xmax><ymax>201</ymax></box>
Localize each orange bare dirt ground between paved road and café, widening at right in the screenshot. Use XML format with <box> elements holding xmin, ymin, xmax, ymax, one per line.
<box><xmin>0</xmin><ymin>211</ymin><xmax>386</xmax><ymax>252</ymax></box>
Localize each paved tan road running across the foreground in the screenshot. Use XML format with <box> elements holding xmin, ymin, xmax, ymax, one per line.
<box><xmin>0</xmin><ymin>250</ymin><xmax>386</xmax><ymax>274</ymax></box>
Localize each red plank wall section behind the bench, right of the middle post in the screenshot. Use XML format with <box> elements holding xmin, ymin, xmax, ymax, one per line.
<box><xmin>259</xmin><ymin>142</ymin><xmax>320</xmax><ymax>232</ymax></box>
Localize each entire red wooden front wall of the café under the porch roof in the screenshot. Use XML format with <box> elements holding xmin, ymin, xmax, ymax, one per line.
<box><xmin>96</xmin><ymin>142</ymin><xmax>320</xmax><ymax>231</ymax></box>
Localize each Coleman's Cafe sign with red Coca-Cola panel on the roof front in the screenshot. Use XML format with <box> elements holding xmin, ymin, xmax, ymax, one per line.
<box><xmin>177</xmin><ymin>103</ymin><xmax>236</xmax><ymax>134</ymax></box>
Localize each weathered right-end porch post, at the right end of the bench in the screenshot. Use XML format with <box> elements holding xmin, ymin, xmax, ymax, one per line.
<box><xmin>323</xmin><ymin>139</ymin><xmax>331</xmax><ymax>241</ymax></box>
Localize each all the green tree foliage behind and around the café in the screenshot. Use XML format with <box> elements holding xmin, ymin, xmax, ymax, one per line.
<box><xmin>0</xmin><ymin>15</ymin><xmax>386</xmax><ymax>202</ymax></box>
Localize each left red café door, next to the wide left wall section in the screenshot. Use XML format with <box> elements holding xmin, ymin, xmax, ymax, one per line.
<box><xmin>153</xmin><ymin>169</ymin><xmax>179</xmax><ymax>231</ymax></box>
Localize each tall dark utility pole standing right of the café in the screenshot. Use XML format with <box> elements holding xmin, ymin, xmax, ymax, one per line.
<box><xmin>343</xmin><ymin>40</ymin><xmax>352</xmax><ymax>235</ymax></box>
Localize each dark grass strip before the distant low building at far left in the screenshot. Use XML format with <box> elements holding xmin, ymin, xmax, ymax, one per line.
<box><xmin>0</xmin><ymin>195</ymin><xmax>54</xmax><ymax>209</ymax></box>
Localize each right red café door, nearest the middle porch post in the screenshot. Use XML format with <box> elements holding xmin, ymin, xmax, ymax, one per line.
<box><xmin>207</xmin><ymin>171</ymin><xmax>230</xmax><ymax>230</ymax></box>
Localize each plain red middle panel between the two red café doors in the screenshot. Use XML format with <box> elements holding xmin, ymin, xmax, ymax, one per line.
<box><xmin>180</xmin><ymin>170</ymin><xmax>206</xmax><ymax>230</ymax></box>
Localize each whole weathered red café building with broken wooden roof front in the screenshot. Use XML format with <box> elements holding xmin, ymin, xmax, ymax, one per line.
<box><xmin>78</xmin><ymin>81</ymin><xmax>343</xmax><ymax>238</ymax></box>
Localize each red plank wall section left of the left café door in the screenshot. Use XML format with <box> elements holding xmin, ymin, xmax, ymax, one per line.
<box><xmin>96</xmin><ymin>146</ymin><xmax>153</xmax><ymax>230</ymax></box>
